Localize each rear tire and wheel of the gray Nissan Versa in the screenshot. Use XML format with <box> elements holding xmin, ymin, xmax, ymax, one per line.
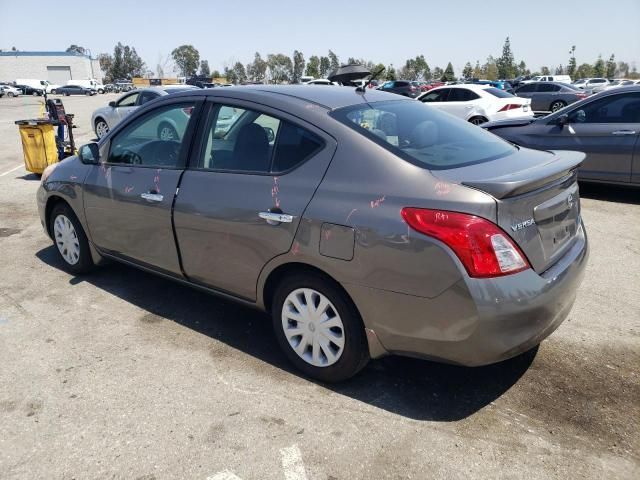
<box><xmin>271</xmin><ymin>273</ymin><xmax>369</xmax><ymax>382</ymax></box>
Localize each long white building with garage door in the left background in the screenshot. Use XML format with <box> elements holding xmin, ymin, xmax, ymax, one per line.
<box><xmin>0</xmin><ymin>51</ymin><xmax>104</xmax><ymax>85</ymax></box>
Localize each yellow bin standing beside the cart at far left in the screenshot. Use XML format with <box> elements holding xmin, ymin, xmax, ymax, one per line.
<box><xmin>16</xmin><ymin>120</ymin><xmax>58</xmax><ymax>174</ymax></box>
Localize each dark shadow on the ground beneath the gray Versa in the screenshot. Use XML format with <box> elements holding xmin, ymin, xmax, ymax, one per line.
<box><xmin>36</xmin><ymin>246</ymin><xmax>537</xmax><ymax>421</ymax></box>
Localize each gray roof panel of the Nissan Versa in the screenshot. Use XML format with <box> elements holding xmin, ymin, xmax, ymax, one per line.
<box><xmin>170</xmin><ymin>85</ymin><xmax>413</xmax><ymax>110</ymax></box>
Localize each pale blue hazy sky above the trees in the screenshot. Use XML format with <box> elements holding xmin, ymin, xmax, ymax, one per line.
<box><xmin>0</xmin><ymin>0</ymin><xmax>640</xmax><ymax>73</ymax></box>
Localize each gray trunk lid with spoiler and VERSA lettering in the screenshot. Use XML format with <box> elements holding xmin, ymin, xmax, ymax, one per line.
<box><xmin>433</xmin><ymin>149</ymin><xmax>585</xmax><ymax>273</ymax></box>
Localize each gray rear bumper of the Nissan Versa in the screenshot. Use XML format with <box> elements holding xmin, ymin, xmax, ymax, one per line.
<box><xmin>347</xmin><ymin>221</ymin><xmax>589</xmax><ymax>366</ymax></box>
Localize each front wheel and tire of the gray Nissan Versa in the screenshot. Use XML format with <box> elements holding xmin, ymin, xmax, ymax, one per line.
<box><xmin>49</xmin><ymin>202</ymin><xmax>94</xmax><ymax>275</ymax></box>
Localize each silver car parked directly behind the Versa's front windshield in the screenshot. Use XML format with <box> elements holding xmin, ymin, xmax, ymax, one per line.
<box><xmin>91</xmin><ymin>85</ymin><xmax>198</xmax><ymax>139</ymax></box>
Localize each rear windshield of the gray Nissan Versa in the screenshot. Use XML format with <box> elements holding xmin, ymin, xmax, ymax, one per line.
<box><xmin>330</xmin><ymin>101</ymin><xmax>515</xmax><ymax>170</ymax></box>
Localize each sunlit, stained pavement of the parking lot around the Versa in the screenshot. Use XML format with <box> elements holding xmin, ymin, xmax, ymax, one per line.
<box><xmin>0</xmin><ymin>95</ymin><xmax>640</xmax><ymax>480</ymax></box>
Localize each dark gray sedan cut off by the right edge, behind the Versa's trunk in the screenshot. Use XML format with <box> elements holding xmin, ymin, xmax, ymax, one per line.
<box><xmin>482</xmin><ymin>86</ymin><xmax>640</xmax><ymax>186</ymax></box>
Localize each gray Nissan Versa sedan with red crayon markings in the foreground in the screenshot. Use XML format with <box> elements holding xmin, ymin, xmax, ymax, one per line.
<box><xmin>38</xmin><ymin>86</ymin><xmax>588</xmax><ymax>381</ymax></box>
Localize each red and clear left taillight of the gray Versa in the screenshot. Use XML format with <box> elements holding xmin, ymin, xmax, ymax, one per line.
<box><xmin>401</xmin><ymin>207</ymin><xmax>529</xmax><ymax>278</ymax></box>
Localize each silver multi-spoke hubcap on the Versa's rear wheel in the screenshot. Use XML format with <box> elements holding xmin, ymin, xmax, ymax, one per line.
<box><xmin>282</xmin><ymin>288</ymin><xmax>345</xmax><ymax>367</ymax></box>
